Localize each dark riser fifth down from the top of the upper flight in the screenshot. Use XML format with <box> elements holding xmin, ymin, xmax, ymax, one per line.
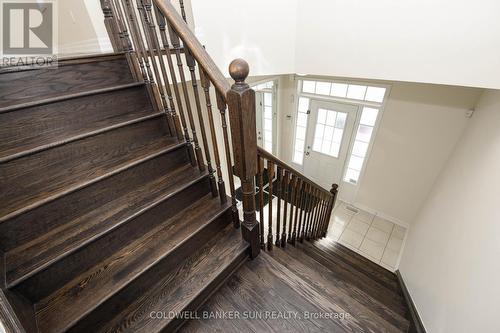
<box><xmin>15</xmin><ymin>177</ymin><xmax>209</xmax><ymax>303</ymax></box>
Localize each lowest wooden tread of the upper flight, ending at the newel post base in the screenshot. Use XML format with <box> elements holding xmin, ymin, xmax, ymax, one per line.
<box><xmin>98</xmin><ymin>225</ymin><xmax>249</xmax><ymax>333</ymax></box>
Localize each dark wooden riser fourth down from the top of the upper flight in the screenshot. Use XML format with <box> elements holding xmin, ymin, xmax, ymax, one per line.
<box><xmin>0</xmin><ymin>146</ymin><xmax>189</xmax><ymax>252</ymax></box>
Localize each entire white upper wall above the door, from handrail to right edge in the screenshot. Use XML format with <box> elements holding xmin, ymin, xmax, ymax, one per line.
<box><xmin>192</xmin><ymin>0</ymin><xmax>500</xmax><ymax>88</ymax></box>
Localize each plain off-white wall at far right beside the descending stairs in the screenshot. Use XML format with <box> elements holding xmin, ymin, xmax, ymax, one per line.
<box><xmin>400</xmin><ymin>91</ymin><xmax>500</xmax><ymax>333</ymax></box>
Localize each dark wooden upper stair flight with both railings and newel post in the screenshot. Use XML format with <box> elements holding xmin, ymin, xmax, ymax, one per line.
<box><xmin>0</xmin><ymin>0</ymin><xmax>337</xmax><ymax>333</ymax></box>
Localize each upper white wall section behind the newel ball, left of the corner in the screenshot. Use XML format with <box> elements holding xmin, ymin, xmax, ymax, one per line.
<box><xmin>191</xmin><ymin>0</ymin><xmax>298</xmax><ymax>76</ymax></box>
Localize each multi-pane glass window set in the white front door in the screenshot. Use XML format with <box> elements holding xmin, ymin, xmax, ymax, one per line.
<box><xmin>313</xmin><ymin>108</ymin><xmax>347</xmax><ymax>158</ymax></box>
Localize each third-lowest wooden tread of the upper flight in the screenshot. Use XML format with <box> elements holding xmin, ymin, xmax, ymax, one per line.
<box><xmin>5</xmin><ymin>165</ymin><xmax>206</xmax><ymax>286</ymax></box>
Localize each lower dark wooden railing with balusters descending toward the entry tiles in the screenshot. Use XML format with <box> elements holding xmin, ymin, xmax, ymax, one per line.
<box><xmin>257</xmin><ymin>147</ymin><xmax>338</xmax><ymax>250</ymax></box>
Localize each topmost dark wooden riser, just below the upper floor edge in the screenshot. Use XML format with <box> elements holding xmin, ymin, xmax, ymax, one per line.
<box><xmin>0</xmin><ymin>55</ymin><xmax>134</xmax><ymax>108</ymax></box>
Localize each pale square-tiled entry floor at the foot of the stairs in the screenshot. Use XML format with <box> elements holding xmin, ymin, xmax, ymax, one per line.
<box><xmin>327</xmin><ymin>201</ymin><xmax>406</xmax><ymax>271</ymax></box>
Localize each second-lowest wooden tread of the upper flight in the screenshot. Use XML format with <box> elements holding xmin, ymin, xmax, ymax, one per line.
<box><xmin>35</xmin><ymin>194</ymin><xmax>234</xmax><ymax>332</ymax></box>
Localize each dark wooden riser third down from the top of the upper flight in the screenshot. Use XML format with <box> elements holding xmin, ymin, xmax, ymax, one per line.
<box><xmin>0</xmin><ymin>117</ymin><xmax>172</xmax><ymax>216</ymax></box>
